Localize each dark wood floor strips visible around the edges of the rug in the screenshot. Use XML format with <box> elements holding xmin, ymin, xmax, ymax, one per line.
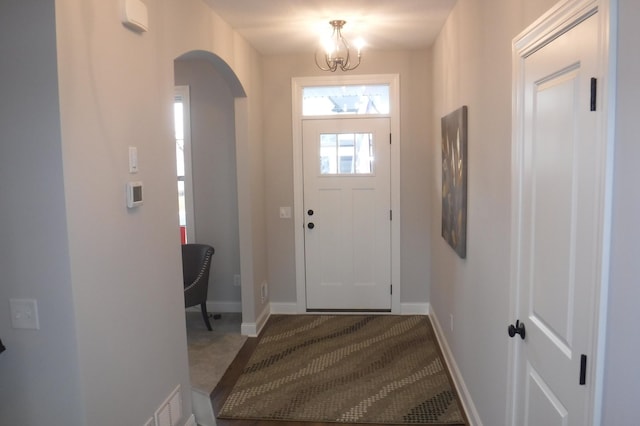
<box><xmin>211</xmin><ymin>316</ymin><xmax>469</xmax><ymax>426</ymax></box>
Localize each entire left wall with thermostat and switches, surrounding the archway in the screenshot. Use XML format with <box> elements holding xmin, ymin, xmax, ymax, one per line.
<box><xmin>0</xmin><ymin>0</ymin><xmax>266</xmax><ymax>426</ymax></box>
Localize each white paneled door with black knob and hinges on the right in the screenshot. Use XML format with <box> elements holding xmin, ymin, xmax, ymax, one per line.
<box><xmin>510</xmin><ymin>5</ymin><xmax>605</xmax><ymax>426</ymax></box>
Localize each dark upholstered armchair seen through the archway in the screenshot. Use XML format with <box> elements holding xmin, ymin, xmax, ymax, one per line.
<box><xmin>182</xmin><ymin>244</ymin><xmax>214</xmax><ymax>331</ymax></box>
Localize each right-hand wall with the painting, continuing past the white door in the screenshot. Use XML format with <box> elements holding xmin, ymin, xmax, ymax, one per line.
<box><xmin>430</xmin><ymin>0</ymin><xmax>640</xmax><ymax>425</ymax></box>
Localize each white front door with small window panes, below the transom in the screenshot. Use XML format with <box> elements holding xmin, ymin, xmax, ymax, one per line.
<box><xmin>302</xmin><ymin>118</ymin><xmax>391</xmax><ymax>310</ymax></box>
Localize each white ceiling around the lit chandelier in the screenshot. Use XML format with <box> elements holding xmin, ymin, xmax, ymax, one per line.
<box><xmin>204</xmin><ymin>0</ymin><xmax>456</xmax><ymax>55</ymax></box>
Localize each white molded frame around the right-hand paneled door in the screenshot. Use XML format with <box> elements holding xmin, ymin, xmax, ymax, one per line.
<box><xmin>505</xmin><ymin>0</ymin><xmax>617</xmax><ymax>426</ymax></box>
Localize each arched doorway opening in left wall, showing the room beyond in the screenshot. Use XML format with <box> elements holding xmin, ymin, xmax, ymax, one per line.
<box><xmin>174</xmin><ymin>51</ymin><xmax>251</xmax><ymax>425</ymax></box>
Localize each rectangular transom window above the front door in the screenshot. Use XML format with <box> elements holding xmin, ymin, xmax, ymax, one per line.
<box><xmin>302</xmin><ymin>84</ymin><xmax>389</xmax><ymax>117</ymax></box>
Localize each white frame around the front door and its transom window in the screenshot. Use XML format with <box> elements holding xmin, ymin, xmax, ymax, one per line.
<box><xmin>291</xmin><ymin>74</ymin><xmax>401</xmax><ymax>314</ymax></box>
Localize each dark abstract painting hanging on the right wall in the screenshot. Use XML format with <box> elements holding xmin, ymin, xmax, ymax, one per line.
<box><xmin>441</xmin><ymin>106</ymin><xmax>468</xmax><ymax>259</ymax></box>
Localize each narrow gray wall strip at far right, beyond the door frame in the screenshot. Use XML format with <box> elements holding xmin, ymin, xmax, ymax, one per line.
<box><xmin>602</xmin><ymin>0</ymin><xmax>640</xmax><ymax>425</ymax></box>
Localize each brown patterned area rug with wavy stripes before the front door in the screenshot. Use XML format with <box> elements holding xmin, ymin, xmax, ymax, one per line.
<box><xmin>218</xmin><ymin>315</ymin><xmax>465</xmax><ymax>425</ymax></box>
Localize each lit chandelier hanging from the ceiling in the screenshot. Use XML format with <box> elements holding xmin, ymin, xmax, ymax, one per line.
<box><xmin>315</xmin><ymin>19</ymin><xmax>364</xmax><ymax>72</ymax></box>
